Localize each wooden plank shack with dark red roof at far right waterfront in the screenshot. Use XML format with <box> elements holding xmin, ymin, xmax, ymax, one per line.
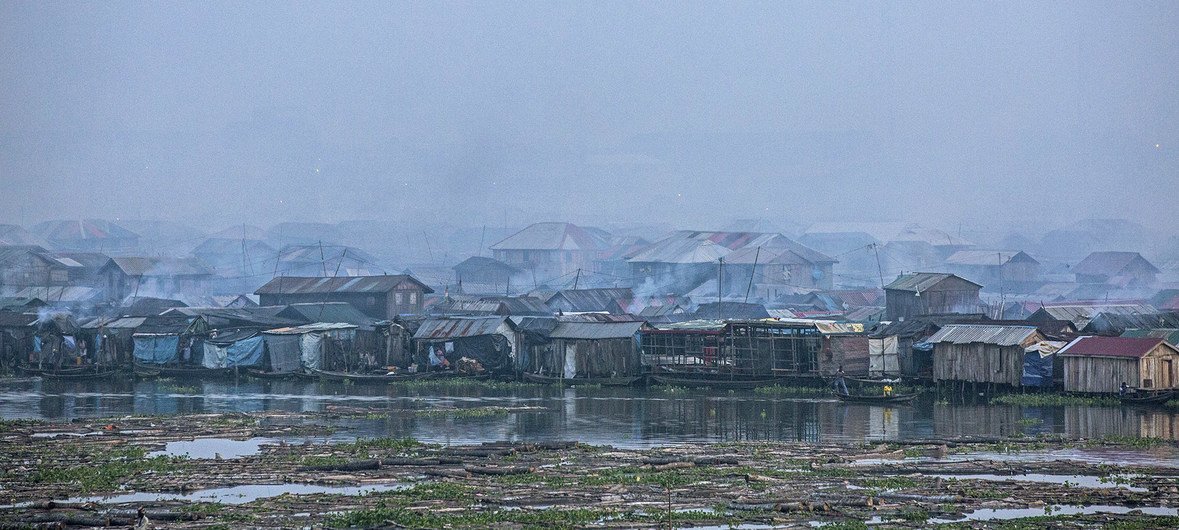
<box><xmin>1059</xmin><ymin>337</ymin><xmax>1179</xmax><ymax>393</ymax></box>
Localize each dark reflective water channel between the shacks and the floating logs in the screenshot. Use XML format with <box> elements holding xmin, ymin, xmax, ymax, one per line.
<box><xmin>0</xmin><ymin>379</ymin><xmax>1179</xmax><ymax>449</ymax></box>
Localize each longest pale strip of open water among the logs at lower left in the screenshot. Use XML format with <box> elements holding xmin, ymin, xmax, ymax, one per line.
<box><xmin>65</xmin><ymin>484</ymin><xmax>407</xmax><ymax>504</ymax></box>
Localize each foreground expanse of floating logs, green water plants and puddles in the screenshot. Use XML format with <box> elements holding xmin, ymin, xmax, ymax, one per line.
<box><xmin>0</xmin><ymin>410</ymin><xmax>1179</xmax><ymax>529</ymax></box>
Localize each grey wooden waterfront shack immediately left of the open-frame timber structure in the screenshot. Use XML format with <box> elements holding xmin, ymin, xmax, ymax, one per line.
<box><xmin>528</xmin><ymin>322</ymin><xmax>644</xmax><ymax>379</ymax></box>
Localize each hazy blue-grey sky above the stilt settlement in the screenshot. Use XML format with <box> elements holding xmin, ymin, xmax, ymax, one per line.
<box><xmin>0</xmin><ymin>1</ymin><xmax>1179</xmax><ymax>228</ymax></box>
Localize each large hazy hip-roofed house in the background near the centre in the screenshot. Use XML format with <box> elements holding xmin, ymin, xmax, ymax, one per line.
<box><xmin>492</xmin><ymin>223</ymin><xmax>610</xmax><ymax>285</ymax></box>
